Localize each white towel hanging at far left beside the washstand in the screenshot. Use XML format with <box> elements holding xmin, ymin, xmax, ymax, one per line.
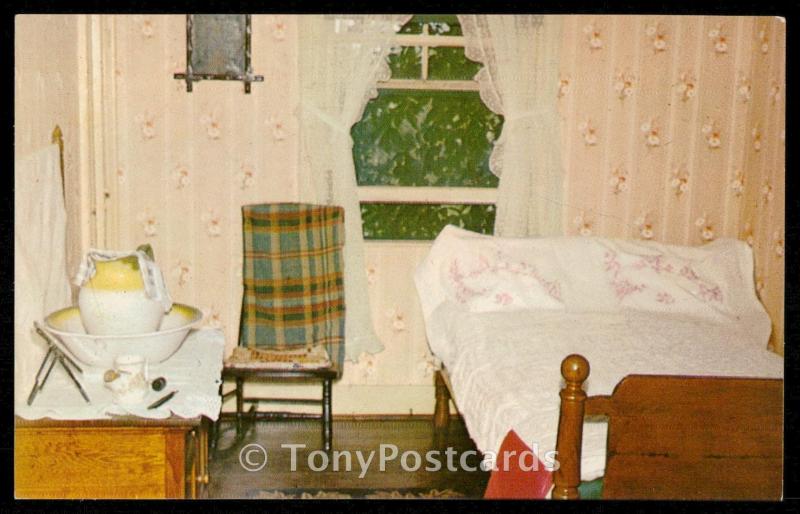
<box><xmin>14</xmin><ymin>145</ymin><xmax>70</xmax><ymax>402</ymax></box>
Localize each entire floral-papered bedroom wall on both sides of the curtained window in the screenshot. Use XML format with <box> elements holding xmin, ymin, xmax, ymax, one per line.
<box><xmin>54</xmin><ymin>15</ymin><xmax>785</xmax><ymax>414</ymax></box>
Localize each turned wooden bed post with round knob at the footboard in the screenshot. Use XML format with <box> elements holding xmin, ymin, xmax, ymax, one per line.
<box><xmin>552</xmin><ymin>354</ymin><xmax>589</xmax><ymax>500</ymax></box>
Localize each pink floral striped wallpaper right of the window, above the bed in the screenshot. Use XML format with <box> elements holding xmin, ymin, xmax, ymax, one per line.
<box><xmin>556</xmin><ymin>16</ymin><xmax>786</xmax><ymax>353</ymax></box>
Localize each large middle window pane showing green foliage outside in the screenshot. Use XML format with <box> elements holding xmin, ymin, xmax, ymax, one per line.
<box><xmin>351</xmin><ymin>89</ymin><xmax>503</xmax><ymax>187</ymax></box>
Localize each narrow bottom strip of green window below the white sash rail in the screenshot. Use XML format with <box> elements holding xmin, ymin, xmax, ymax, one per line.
<box><xmin>361</xmin><ymin>203</ymin><xmax>495</xmax><ymax>240</ymax></box>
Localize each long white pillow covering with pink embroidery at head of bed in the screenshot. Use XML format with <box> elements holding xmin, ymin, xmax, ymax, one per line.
<box><xmin>414</xmin><ymin>225</ymin><xmax>771</xmax><ymax>350</ymax></box>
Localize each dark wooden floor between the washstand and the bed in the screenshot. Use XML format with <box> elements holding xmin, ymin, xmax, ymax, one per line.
<box><xmin>209</xmin><ymin>418</ymin><xmax>489</xmax><ymax>498</ymax></box>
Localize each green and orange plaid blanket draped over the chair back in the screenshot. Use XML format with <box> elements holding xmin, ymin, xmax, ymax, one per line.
<box><xmin>239</xmin><ymin>203</ymin><xmax>345</xmax><ymax>369</ymax></box>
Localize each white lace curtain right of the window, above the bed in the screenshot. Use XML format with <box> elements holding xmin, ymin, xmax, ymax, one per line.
<box><xmin>458</xmin><ymin>15</ymin><xmax>564</xmax><ymax>237</ymax></box>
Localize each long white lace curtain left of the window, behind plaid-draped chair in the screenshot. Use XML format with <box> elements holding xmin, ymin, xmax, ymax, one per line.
<box><xmin>298</xmin><ymin>15</ymin><xmax>410</xmax><ymax>361</ymax></box>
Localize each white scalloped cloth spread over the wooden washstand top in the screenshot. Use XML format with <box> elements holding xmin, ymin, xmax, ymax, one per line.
<box><xmin>15</xmin><ymin>329</ymin><xmax>225</xmax><ymax>420</ymax></box>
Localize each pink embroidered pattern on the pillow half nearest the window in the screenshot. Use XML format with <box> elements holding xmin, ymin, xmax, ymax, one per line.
<box><xmin>449</xmin><ymin>251</ymin><xmax>561</xmax><ymax>305</ymax></box>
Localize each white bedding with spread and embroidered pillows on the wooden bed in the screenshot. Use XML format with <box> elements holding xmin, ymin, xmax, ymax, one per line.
<box><xmin>415</xmin><ymin>226</ymin><xmax>783</xmax><ymax>496</ymax></box>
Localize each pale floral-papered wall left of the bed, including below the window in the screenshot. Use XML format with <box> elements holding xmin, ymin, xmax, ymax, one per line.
<box><xmin>80</xmin><ymin>15</ymin><xmax>440</xmax><ymax>413</ymax></box>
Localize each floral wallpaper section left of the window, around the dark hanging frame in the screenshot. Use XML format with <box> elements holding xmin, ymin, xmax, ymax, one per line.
<box><xmin>104</xmin><ymin>15</ymin><xmax>297</xmax><ymax>351</ymax></box>
